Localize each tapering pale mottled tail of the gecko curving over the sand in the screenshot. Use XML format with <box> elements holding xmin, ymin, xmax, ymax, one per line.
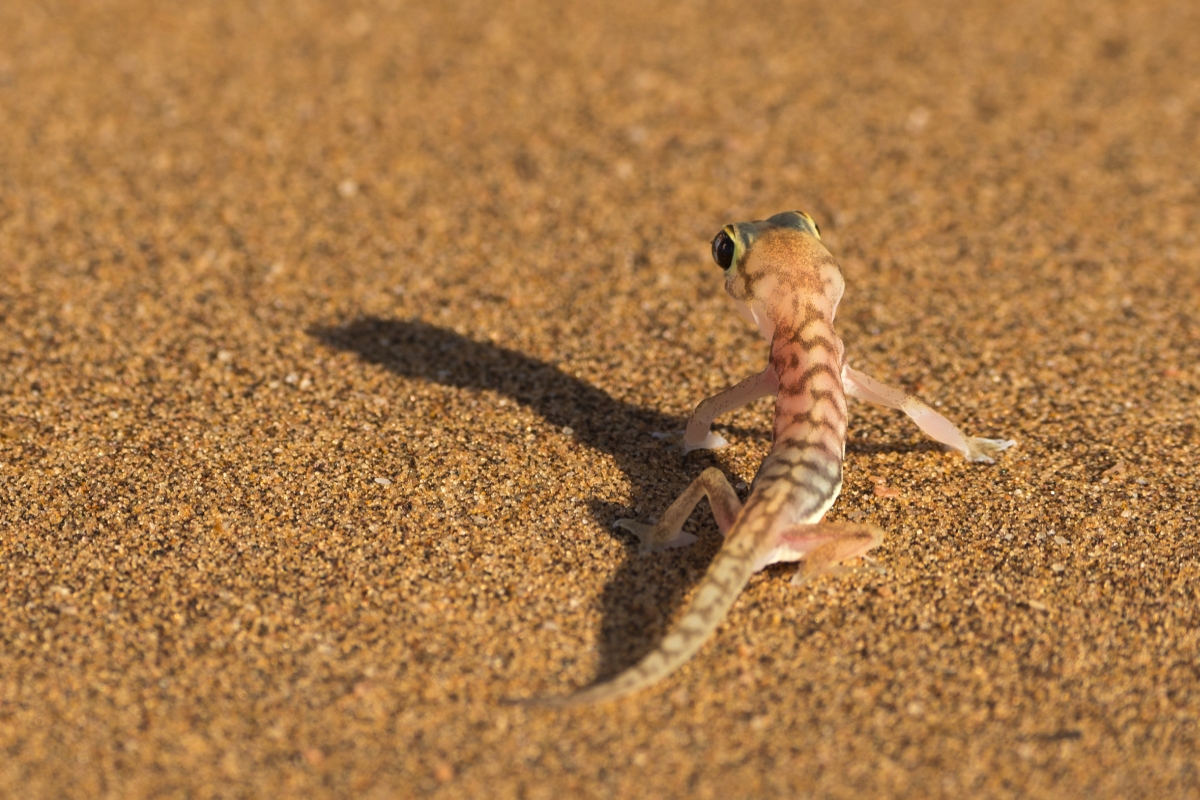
<box><xmin>521</xmin><ymin>530</ymin><xmax>757</xmax><ymax>708</ymax></box>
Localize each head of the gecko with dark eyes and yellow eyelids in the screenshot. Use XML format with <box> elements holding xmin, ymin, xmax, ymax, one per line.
<box><xmin>713</xmin><ymin>211</ymin><xmax>845</xmax><ymax>341</ymax></box>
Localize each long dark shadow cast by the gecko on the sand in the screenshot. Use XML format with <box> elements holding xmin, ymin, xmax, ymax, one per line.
<box><xmin>308</xmin><ymin>317</ymin><xmax>770</xmax><ymax>680</ymax></box>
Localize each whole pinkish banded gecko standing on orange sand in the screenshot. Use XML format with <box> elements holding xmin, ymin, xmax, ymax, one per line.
<box><xmin>532</xmin><ymin>211</ymin><xmax>1015</xmax><ymax>706</ymax></box>
